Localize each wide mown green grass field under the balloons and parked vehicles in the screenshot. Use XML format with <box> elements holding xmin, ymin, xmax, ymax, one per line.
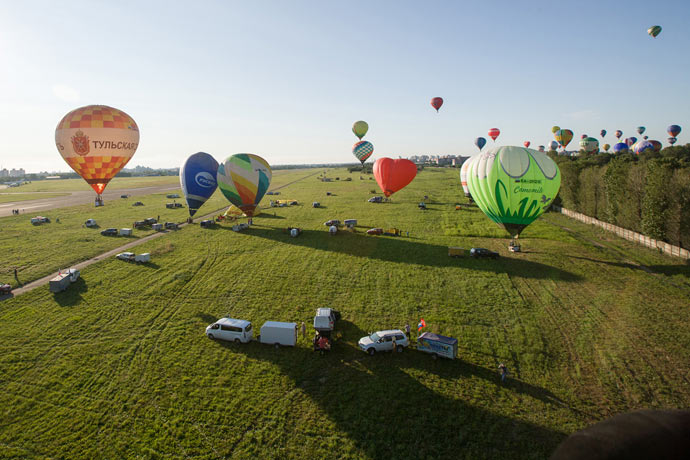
<box><xmin>0</xmin><ymin>169</ymin><xmax>690</xmax><ymax>459</ymax></box>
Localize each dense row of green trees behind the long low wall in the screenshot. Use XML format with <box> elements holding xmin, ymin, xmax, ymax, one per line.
<box><xmin>550</xmin><ymin>144</ymin><xmax>690</xmax><ymax>248</ymax></box>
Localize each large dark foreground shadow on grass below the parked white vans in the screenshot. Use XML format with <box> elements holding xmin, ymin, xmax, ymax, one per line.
<box><xmin>223</xmin><ymin>324</ymin><xmax>565</xmax><ymax>460</ymax></box>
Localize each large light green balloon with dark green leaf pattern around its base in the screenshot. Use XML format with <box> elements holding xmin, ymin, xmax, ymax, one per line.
<box><xmin>467</xmin><ymin>146</ymin><xmax>561</xmax><ymax>236</ymax></box>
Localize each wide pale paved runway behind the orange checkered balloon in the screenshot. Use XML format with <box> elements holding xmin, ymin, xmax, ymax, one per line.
<box><xmin>0</xmin><ymin>184</ymin><xmax>180</xmax><ymax>217</ymax></box>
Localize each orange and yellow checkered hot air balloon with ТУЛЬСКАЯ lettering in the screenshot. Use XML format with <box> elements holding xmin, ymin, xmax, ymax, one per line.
<box><xmin>55</xmin><ymin>105</ymin><xmax>139</xmax><ymax>205</ymax></box>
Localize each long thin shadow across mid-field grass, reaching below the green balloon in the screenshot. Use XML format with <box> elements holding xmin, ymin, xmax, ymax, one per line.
<box><xmin>246</xmin><ymin>225</ymin><xmax>581</xmax><ymax>281</ymax></box>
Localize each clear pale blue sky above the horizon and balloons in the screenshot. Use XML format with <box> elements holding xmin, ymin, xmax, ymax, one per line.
<box><xmin>0</xmin><ymin>0</ymin><xmax>690</xmax><ymax>172</ymax></box>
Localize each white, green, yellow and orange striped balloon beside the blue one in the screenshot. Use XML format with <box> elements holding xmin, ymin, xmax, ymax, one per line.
<box><xmin>216</xmin><ymin>153</ymin><xmax>273</xmax><ymax>217</ymax></box>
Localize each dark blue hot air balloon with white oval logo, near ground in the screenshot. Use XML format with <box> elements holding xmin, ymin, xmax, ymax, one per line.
<box><xmin>180</xmin><ymin>152</ymin><xmax>218</xmax><ymax>217</ymax></box>
